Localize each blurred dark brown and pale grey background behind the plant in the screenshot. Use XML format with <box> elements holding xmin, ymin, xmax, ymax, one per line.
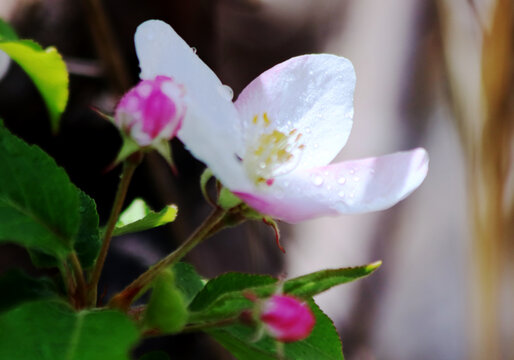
<box><xmin>0</xmin><ymin>0</ymin><xmax>514</xmax><ymax>360</ymax></box>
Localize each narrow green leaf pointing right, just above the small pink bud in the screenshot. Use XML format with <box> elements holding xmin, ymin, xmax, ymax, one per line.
<box><xmin>284</xmin><ymin>261</ymin><xmax>382</xmax><ymax>298</ymax></box>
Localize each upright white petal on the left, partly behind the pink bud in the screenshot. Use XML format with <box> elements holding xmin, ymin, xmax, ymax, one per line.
<box><xmin>135</xmin><ymin>20</ymin><xmax>250</xmax><ymax>189</ymax></box>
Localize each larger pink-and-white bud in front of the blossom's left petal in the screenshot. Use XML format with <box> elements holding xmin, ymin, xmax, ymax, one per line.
<box><xmin>114</xmin><ymin>76</ymin><xmax>186</xmax><ymax>146</ymax></box>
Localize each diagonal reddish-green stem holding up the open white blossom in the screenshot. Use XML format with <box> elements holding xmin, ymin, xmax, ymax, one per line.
<box><xmin>108</xmin><ymin>207</ymin><xmax>226</xmax><ymax>311</ymax></box>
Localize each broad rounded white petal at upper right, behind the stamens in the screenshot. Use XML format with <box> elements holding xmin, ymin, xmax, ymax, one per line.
<box><xmin>235</xmin><ymin>54</ymin><xmax>355</xmax><ymax>169</ymax></box>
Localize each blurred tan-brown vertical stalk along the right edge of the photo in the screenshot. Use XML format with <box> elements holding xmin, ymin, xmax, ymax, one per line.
<box><xmin>439</xmin><ymin>0</ymin><xmax>514</xmax><ymax>359</ymax></box>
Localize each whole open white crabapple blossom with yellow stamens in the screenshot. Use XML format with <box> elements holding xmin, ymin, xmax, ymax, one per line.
<box><xmin>135</xmin><ymin>20</ymin><xmax>428</xmax><ymax>223</ymax></box>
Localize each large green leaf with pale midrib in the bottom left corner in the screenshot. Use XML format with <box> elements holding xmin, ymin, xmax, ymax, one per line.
<box><xmin>0</xmin><ymin>301</ymin><xmax>139</xmax><ymax>360</ymax></box>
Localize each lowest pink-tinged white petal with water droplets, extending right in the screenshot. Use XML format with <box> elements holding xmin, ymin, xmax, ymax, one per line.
<box><xmin>236</xmin><ymin>148</ymin><xmax>429</xmax><ymax>223</ymax></box>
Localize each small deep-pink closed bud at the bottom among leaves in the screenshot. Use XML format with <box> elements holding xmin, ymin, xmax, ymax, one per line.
<box><xmin>260</xmin><ymin>295</ymin><xmax>316</xmax><ymax>342</ymax></box>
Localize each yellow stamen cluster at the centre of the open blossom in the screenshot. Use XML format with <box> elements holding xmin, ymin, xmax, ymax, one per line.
<box><xmin>243</xmin><ymin>113</ymin><xmax>305</xmax><ymax>186</ymax></box>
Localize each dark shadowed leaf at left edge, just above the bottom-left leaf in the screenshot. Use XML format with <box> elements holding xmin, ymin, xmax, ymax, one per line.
<box><xmin>0</xmin><ymin>269</ymin><xmax>57</xmax><ymax>313</ymax></box>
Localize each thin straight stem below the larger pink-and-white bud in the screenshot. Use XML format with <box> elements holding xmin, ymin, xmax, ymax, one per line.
<box><xmin>88</xmin><ymin>158</ymin><xmax>141</xmax><ymax>306</ymax></box>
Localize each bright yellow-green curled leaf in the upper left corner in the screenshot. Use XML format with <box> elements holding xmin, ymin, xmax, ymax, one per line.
<box><xmin>0</xmin><ymin>39</ymin><xmax>68</xmax><ymax>132</ymax></box>
